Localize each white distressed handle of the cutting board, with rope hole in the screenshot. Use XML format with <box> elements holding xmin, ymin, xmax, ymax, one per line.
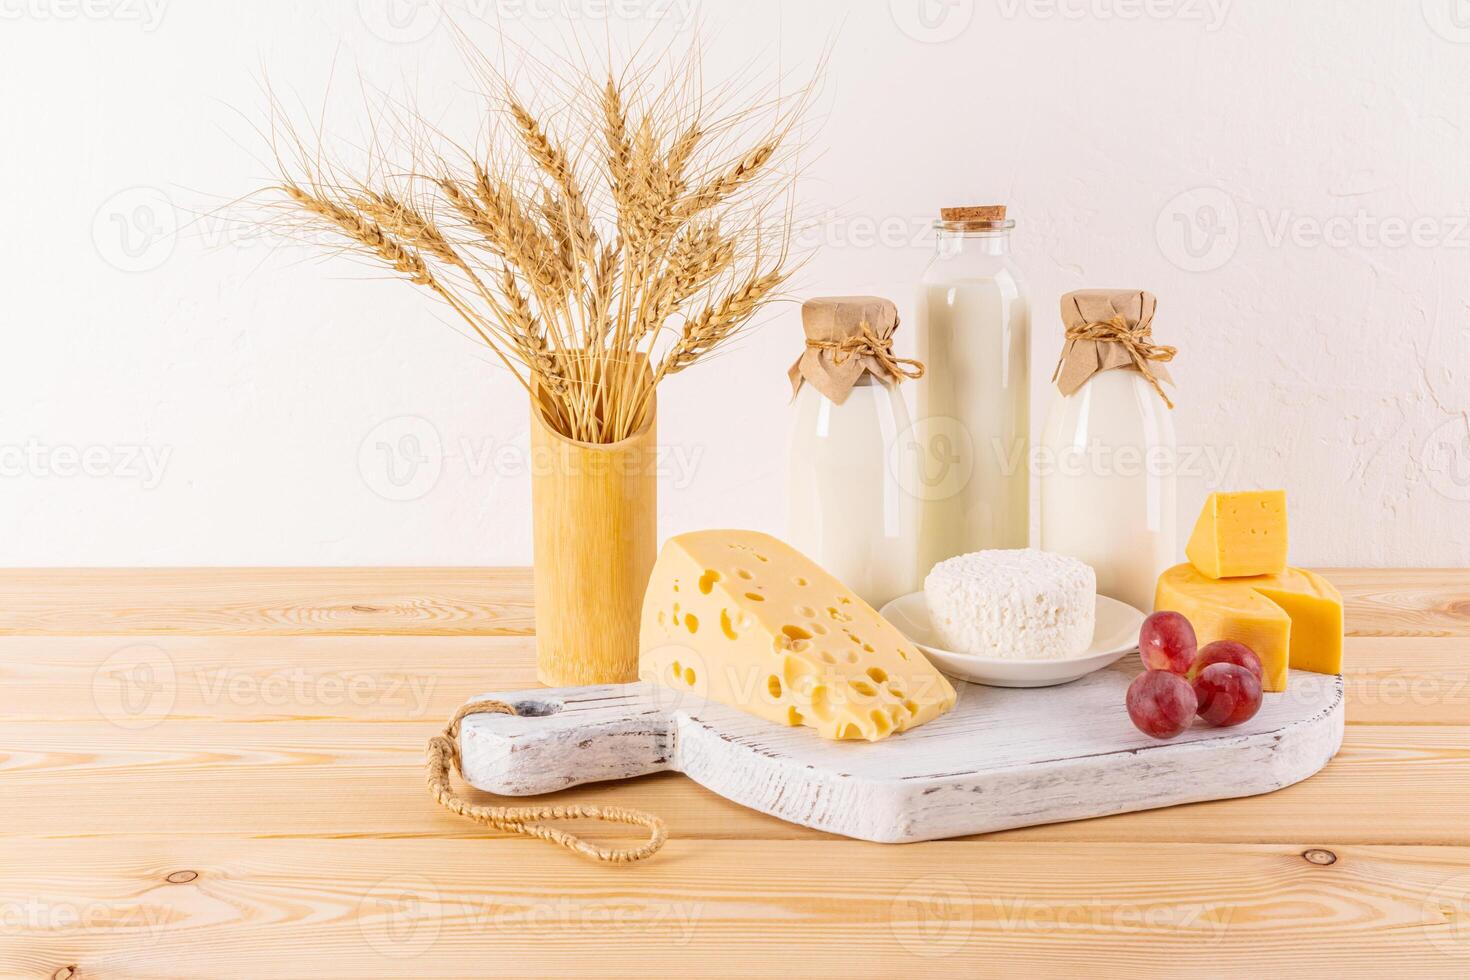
<box><xmin>460</xmin><ymin>683</ymin><xmax>678</xmax><ymax>796</ymax></box>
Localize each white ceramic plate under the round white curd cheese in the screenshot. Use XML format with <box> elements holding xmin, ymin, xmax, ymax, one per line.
<box><xmin>879</xmin><ymin>592</ymin><xmax>1144</xmax><ymax>688</ymax></box>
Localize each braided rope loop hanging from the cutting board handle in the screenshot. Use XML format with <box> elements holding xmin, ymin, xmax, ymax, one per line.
<box><xmin>426</xmin><ymin>699</ymin><xmax>669</xmax><ymax>864</ymax></box>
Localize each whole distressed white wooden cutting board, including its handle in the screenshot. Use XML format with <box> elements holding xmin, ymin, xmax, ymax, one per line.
<box><xmin>460</xmin><ymin>667</ymin><xmax>1344</xmax><ymax>843</ymax></box>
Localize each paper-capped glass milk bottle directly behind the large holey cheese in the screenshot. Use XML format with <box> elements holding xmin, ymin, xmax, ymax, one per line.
<box><xmin>786</xmin><ymin>297</ymin><xmax>923</xmax><ymax>608</ymax></box>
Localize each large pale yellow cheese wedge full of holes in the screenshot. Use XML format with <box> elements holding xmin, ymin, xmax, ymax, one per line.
<box><xmin>638</xmin><ymin>530</ymin><xmax>954</xmax><ymax>742</ymax></box>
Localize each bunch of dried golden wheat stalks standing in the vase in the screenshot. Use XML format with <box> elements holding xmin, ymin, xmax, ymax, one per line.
<box><xmin>264</xmin><ymin>47</ymin><xmax>809</xmax><ymax>442</ymax></box>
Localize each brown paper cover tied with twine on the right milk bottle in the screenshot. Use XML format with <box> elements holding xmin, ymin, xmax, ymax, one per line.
<box><xmin>1053</xmin><ymin>289</ymin><xmax>1176</xmax><ymax>408</ymax></box>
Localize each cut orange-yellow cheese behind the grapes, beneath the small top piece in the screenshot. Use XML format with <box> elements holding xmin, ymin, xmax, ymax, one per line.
<box><xmin>1154</xmin><ymin>563</ymin><xmax>1342</xmax><ymax>691</ymax></box>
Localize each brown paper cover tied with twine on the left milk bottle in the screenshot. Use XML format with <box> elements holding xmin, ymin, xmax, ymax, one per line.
<box><xmin>786</xmin><ymin>295</ymin><xmax>923</xmax><ymax>404</ymax></box>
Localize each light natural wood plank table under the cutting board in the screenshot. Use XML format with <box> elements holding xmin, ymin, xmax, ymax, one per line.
<box><xmin>0</xmin><ymin>569</ymin><xmax>1470</xmax><ymax>980</ymax></box>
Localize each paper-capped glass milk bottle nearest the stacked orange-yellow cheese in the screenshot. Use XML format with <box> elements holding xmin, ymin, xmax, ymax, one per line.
<box><xmin>1036</xmin><ymin>289</ymin><xmax>1177</xmax><ymax>613</ymax></box>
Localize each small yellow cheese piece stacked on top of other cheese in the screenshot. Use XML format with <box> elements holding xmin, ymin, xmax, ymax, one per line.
<box><xmin>1185</xmin><ymin>491</ymin><xmax>1286</xmax><ymax>579</ymax></box>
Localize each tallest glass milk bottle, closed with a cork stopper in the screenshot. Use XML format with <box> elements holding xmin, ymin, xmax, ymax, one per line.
<box><xmin>916</xmin><ymin>206</ymin><xmax>1030</xmax><ymax>570</ymax></box>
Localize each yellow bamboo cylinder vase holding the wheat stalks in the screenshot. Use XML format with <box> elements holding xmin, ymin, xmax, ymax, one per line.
<box><xmin>531</xmin><ymin>393</ymin><xmax>659</xmax><ymax>688</ymax></box>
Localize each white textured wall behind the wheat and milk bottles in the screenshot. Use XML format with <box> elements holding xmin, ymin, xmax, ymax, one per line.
<box><xmin>0</xmin><ymin>0</ymin><xmax>1470</xmax><ymax>566</ymax></box>
